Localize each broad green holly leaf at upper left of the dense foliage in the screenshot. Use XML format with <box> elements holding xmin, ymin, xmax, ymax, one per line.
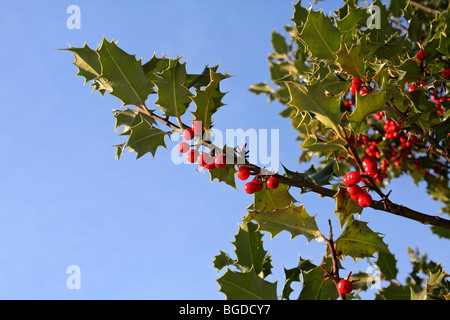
<box><xmin>299</xmin><ymin>8</ymin><xmax>341</xmax><ymax>61</ymax></box>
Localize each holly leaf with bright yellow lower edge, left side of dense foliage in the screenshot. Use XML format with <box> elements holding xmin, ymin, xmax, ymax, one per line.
<box><xmin>286</xmin><ymin>82</ymin><xmax>343</xmax><ymax>131</ymax></box>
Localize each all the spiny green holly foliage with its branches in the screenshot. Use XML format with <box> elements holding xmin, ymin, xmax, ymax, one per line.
<box><xmin>65</xmin><ymin>0</ymin><xmax>450</xmax><ymax>300</ymax></box>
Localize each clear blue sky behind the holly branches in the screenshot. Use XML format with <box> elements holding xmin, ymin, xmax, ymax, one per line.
<box><xmin>0</xmin><ymin>0</ymin><xmax>450</xmax><ymax>299</ymax></box>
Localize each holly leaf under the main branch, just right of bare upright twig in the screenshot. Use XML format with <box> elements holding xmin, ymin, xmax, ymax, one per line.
<box><xmin>335</xmin><ymin>220</ymin><xmax>389</xmax><ymax>261</ymax></box>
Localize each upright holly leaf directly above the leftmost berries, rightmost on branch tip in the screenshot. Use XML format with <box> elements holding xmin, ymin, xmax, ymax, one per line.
<box><xmin>192</xmin><ymin>69</ymin><xmax>230</xmax><ymax>130</ymax></box>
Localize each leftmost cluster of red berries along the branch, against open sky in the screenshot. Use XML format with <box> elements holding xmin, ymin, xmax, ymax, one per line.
<box><xmin>178</xmin><ymin>121</ymin><xmax>226</xmax><ymax>170</ymax></box>
